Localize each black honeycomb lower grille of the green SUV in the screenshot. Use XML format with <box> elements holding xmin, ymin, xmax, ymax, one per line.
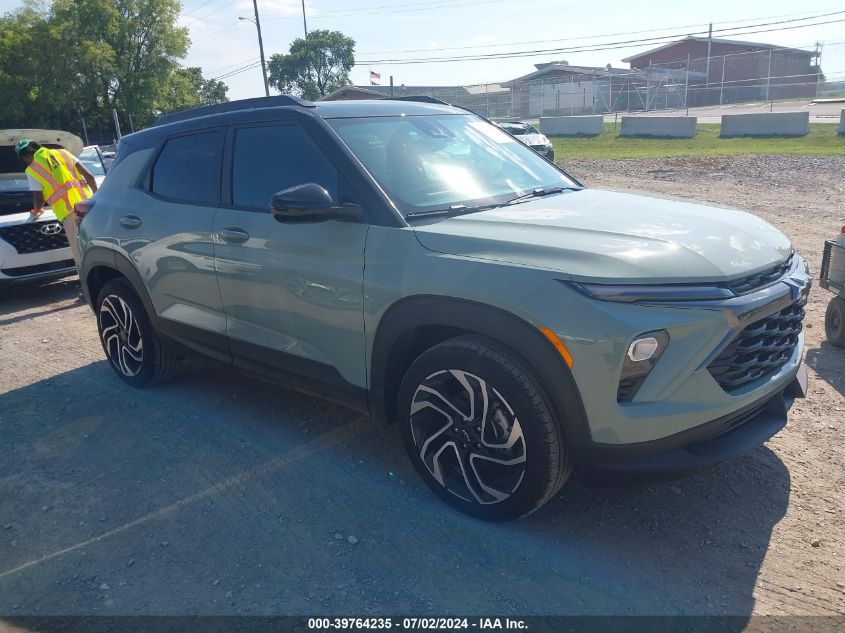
<box><xmin>707</xmin><ymin>294</ymin><xmax>807</xmax><ymax>393</ymax></box>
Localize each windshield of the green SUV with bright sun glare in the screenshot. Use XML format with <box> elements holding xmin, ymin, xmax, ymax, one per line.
<box><xmin>328</xmin><ymin>115</ymin><xmax>578</xmax><ymax>214</ymax></box>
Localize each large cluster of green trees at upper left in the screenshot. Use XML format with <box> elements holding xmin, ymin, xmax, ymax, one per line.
<box><xmin>0</xmin><ymin>0</ymin><xmax>227</xmax><ymax>138</ymax></box>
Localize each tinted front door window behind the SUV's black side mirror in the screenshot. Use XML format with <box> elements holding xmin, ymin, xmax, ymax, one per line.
<box><xmin>232</xmin><ymin>125</ymin><xmax>338</xmax><ymax>209</ymax></box>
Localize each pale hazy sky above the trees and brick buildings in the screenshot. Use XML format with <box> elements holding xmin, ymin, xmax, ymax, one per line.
<box><xmin>0</xmin><ymin>0</ymin><xmax>845</xmax><ymax>99</ymax></box>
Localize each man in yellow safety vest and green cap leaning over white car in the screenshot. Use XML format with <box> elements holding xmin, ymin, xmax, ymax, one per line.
<box><xmin>15</xmin><ymin>139</ymin><xmax>97</xmax><ymax>268</ymax></box>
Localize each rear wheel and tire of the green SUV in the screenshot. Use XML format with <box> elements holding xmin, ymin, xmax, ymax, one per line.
<box><xmin>95</xmin><ymin>279</ymin><xmax>178</xmax><ymax>388</ymax></box>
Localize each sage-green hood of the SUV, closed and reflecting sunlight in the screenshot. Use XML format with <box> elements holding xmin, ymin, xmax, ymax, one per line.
<box><xmin>414</xmin><ymin>189</ymin><xmax>792</xmax><ymax>283</ymax></box>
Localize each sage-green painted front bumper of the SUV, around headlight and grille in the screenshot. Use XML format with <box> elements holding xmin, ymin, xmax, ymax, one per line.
<box><xmin>521</xmin><ymin>256</ymin><xmax>810</xmax><ymax>450</ymax></box>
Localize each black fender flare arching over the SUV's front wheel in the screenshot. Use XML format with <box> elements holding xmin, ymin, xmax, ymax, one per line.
<box><xmin>370</xmin><ymin>295</ymin><xmax>590</xmax><ymax>459</ymax></box>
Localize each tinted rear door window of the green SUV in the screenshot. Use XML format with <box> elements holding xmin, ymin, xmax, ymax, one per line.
<box><xmin>153</xmin><ymin>132</ymin><xmax>219</xmax><ymax>204</ymax></box>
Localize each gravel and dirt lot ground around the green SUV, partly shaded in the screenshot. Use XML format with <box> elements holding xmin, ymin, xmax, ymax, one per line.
<box><xmin>0</xmin><ymin>156</ymin><xmax>845</xmax><ymax>628</ymax></box>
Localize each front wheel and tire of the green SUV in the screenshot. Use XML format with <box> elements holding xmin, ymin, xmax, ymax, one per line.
<box><xmin>398</xmin><ymin>336</ymin><xmax>571</xmax><ymax>521</ymax></box>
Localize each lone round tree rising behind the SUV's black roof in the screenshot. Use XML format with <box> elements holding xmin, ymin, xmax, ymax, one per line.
<box><xmin>267</xmin><ymin>30</ymin><xmax>355</xmax><ymax>100</ymax></box>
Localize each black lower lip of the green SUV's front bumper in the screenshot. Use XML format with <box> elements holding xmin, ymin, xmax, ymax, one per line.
<box><xmin>587</xmin><ymin>365</ymin><xmax>807</xmax><ymax>473</ymax></box>
